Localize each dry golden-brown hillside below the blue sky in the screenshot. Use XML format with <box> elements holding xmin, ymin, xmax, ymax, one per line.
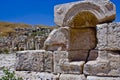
<box><xmin>0</xmin><ymin>22</ymin><xmax>57</xmax><ymax>36</ymax></box>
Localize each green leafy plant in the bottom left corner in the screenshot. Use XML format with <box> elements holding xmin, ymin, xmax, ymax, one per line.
<box><xmin>0</xmin><ymin>68</ymin><xmax>23</xmax><ymax>80</ymax></box>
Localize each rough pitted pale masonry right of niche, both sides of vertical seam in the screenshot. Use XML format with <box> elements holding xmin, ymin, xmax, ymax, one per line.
<box><xmin>97</xmin><ymin>23</ymin><xmax>120</xmax><ymax>50</ymax></box>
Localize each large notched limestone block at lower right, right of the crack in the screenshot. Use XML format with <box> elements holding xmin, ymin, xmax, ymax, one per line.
<box><xmin>84</xmin><ymin>51</ymin><xmax>120</xmax><ymax>76</ymax></box>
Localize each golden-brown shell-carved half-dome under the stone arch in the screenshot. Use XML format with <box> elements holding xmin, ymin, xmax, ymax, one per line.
<box><xmin>69</xmin><ymin>11</ymin><xmax>98</xmax><ymax>28</ymax></box>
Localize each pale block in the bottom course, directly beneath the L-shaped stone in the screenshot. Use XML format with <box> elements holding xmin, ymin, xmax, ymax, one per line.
<box><xmin>59</xmin><ymin>74</ymin><xmax>86</xmax><ymax>80</ymax></box>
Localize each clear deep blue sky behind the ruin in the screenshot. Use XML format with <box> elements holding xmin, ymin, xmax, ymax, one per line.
<box><xmin>0</xmin><ymin>0</ymin><xmax>120</xmax><ymax>26</ymax></box>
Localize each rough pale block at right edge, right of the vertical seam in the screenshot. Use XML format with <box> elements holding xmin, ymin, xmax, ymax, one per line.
<box><xmin>108</xmin><ymin>23</ymin><xmax>120</xmax><ymax>50</ymax></box>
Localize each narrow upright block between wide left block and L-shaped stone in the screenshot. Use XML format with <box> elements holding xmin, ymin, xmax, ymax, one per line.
<box><xmin>43</xmin><ymin>51</ymin><xmax>54</xmax><ymax>72</ymax></box>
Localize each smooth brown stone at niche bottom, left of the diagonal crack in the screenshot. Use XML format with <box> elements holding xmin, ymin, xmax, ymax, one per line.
<box><xmin>68</xmin><ymin>50</ymin><xmax>89</xmax><ymax>61</ymax></box>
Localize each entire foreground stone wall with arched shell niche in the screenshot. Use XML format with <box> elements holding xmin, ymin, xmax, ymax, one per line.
<box><xmin>16</xmin><ymin>0</ymin><xmax>120</xmax><ymax>80</ymax></box>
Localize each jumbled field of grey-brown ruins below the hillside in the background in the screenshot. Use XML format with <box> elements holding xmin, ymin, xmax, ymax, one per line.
<box><xmin>0</xmin><ymin>26</ymin><xmax>52</xmax><ymax>53</ymax></box>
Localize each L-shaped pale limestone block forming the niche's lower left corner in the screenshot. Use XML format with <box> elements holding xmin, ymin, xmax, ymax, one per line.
<box><xmin>54</xmin><ymin>51</ymin><xmax>85</xmax><ymax>74</ymax></box>
